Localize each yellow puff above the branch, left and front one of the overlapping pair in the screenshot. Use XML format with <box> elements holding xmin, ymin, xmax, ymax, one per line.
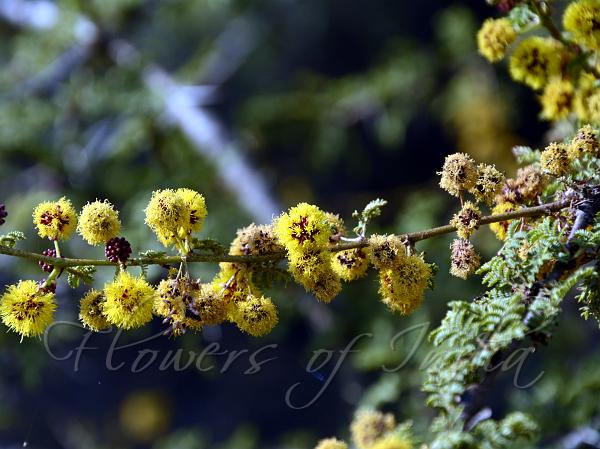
<box><xmin>145</xmin><ymin>189</ymin><xmax>191</xmax><ymax>246</ymax></box>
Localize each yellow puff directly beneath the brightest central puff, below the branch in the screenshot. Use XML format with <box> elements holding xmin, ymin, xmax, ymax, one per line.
<box><xmin>289</xmin><ymin>251</ymin><xmax>342</xmax><ymax>303</ymax></box>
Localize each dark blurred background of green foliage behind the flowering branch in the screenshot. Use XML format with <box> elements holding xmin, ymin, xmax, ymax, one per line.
<box><xmin>0</xmin><ymin>0</ymin><xmax>600</xmax><ymax>449</ymax></box>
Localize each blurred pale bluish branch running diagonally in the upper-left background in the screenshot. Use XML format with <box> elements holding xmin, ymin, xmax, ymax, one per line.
<box><xmin>0</xmin><ymin>0</ymin><xmax>281</xmax><ymax>223</ymax></box>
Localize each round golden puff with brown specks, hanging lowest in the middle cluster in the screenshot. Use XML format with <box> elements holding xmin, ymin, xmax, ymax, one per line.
<box><xmin>233</xmin><ymin>295</ymin><xmax>278</xmax><ymax>337</ymax></box>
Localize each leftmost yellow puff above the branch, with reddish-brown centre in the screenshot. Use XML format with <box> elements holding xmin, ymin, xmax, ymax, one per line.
<box><xmin>33</xmin><ymin>197</ymin><xmax>77</xmax><ymax>240</ymax></box>
